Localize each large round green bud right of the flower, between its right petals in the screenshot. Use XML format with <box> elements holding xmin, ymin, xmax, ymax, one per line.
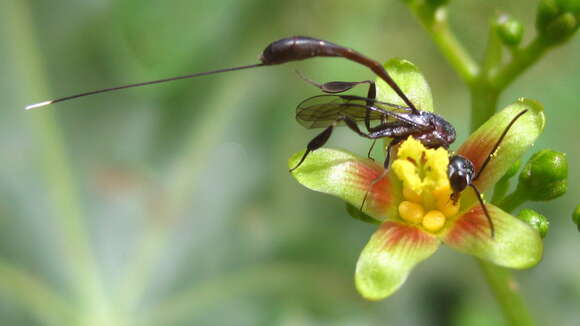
<box><xmin>518</xmin><ymin>149</ymin><xmax>568</xmax><ymax>201</ymax></box>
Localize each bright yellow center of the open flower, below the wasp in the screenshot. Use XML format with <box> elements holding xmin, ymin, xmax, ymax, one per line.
<box><xmin>391</xmin><ymin>137</ymin><xmax>459</xmax><ymax>232</ymax></box>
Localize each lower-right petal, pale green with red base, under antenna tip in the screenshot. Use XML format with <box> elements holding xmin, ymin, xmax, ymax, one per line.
<box><xmin>443</xmin><ymin>204</ymin><xmax>543</xmax><ymax>268</ymax></box>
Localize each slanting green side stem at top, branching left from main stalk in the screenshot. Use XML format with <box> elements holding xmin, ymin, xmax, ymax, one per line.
<box><xmin>409</xmin><ymin>3</ymin><xmax>479</xmax><ymax>85</ymax></box>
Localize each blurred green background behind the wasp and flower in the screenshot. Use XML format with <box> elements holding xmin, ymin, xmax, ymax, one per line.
<box><xmin>0</xmin><ymin>0</ymin><xmax>580</xmax><ymax>326</ymax></box>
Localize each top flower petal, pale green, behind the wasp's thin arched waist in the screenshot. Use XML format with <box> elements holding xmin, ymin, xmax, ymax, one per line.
<box><xmin>375</xmin><ymin>58</ymin><xmax>433</xmax><ymax>112</ymax></box>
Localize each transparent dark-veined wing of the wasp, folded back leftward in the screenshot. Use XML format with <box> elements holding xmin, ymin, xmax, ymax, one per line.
<box><xmin>296</xmin><ymin>95</ymin><xmax>411</xmax><ymax>129</ymax></box>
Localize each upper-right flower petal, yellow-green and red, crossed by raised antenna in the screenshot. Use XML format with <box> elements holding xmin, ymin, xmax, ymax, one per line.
<box><xmin>457</xmin><ymin>99</ymin><xmax>545</xmax><ymax>191</ymax></box>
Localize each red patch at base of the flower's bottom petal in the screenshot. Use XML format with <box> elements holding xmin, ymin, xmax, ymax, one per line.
<box><xmin>379</xmin><ymin>222</ymin><xmax>436</xmax><ymax>250</ymax></box>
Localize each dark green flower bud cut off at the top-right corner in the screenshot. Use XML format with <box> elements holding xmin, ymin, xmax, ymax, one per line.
<box><xmin>536</xmin><ymin>0</ymin><xmax>580</xmax><ymax>44</ymax></box>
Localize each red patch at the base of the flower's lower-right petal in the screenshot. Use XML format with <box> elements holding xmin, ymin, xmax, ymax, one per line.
<box><xmin>447</xmin><ymin>204</ymin><xmax>490</xmax><ymax>245</ymax></box>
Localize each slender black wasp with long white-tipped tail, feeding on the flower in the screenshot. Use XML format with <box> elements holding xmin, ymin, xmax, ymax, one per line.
<box><xmin>26</xmin><ymin>36</ymin><xmax>525</xmax><ymax>235</ymax></box>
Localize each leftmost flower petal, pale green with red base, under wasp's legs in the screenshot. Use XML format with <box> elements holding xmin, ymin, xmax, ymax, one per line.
<box><xmin>288</xmin><ymin>148</ymin><xmax>401</xmax><ymax>221</ymax></box>
